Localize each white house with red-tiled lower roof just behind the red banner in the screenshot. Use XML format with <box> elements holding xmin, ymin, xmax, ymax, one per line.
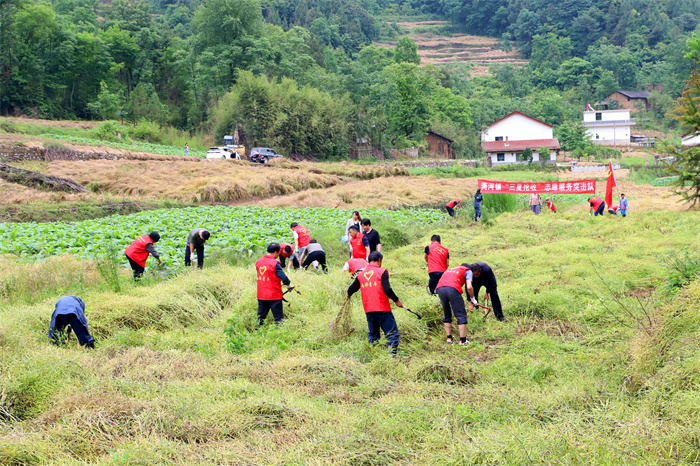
<box><xmin>481</xmin><ymin>112</ymin><xmax>560</xmax><ymax>165</ymax></box>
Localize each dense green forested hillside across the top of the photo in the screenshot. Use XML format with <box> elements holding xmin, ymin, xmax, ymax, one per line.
<box><xmin>0</xmin><ymin>0</ymin><xmax>700</xmax><ymax>158</ymax></box>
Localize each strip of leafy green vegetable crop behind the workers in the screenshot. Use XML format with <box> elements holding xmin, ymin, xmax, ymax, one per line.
<box><xmin>0</xmin><ymin>206</ymin><xmax>445</xmax><ymax>265</ymax></box>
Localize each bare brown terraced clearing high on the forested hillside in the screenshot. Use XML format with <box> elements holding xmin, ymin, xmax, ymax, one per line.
<box><xmin>376</xmin><ymin>21</ymin><xmax>527</xmax><ymax>76</ymax></box>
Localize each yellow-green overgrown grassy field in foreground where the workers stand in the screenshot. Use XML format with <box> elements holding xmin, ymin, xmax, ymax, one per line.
<box><xmin>0</xmin><ymin>204</ymin><xmax>700</xmax><ymax>465</ymax></box>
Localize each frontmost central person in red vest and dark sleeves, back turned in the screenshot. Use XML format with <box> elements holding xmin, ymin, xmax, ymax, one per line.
<box><xmin>348</xmin><ymin>251</ymin><xmax>403</xmax><ymax>355</ymax></box>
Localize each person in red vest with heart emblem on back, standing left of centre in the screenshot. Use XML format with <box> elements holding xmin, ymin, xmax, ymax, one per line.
<box><xmin>255</xmin><ymin>243</ymin><xmax>294</xmax><ymax>326</ymax></box>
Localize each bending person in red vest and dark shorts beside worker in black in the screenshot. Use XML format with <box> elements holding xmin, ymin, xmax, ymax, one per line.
<box><xmin>435</xmin><ymin>264</ymin><xmax>478</xmax><ymax>345</ymax></box>
